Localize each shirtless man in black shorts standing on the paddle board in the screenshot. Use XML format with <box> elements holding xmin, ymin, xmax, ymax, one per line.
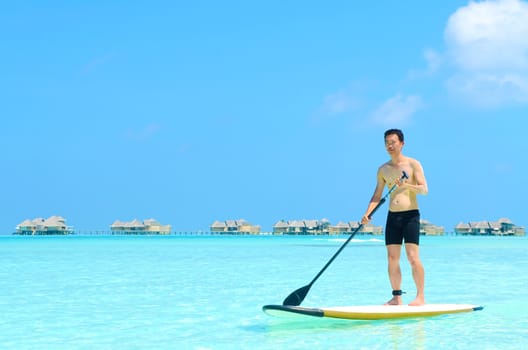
<box><xmin>361</xmin><ymin>129</ymin><xmax>428</xmax><ymax>306</ymax></box>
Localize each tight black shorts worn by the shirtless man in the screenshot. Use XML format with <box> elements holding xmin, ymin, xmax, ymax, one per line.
<box><xmin>385</xmin><ymin>209</ymin><xmax>420</xmax><ymax>245</ymax></box>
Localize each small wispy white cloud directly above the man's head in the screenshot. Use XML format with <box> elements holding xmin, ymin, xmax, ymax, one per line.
<box><xmin>370</xmin><ymin>94</ymin><xmax>423</xmax><ymax>127</ymax></box>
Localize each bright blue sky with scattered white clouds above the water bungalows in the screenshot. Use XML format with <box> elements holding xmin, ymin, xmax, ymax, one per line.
<box><xmin>0</xmin><ymin>0</ymin><xmax>528</xmax><ymax>233</ymax></box>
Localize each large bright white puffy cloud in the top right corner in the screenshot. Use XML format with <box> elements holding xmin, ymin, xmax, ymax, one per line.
<box><xmin>445</xmin><ymin>0</ymin><xmax>528</xmax><ymax>105</ymax></box>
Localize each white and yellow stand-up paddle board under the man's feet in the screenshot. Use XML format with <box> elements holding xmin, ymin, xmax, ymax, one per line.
<box><xmin>262</xmin><ymin>304</ymin><xmax>483</xmax><ymax>320</ymax></box>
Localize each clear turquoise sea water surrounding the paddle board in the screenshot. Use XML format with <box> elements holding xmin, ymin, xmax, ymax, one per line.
<box><xmin>0</xmin><ymin>236</ymin><xmax>528</xmax><ymax>349</ymax></box>
